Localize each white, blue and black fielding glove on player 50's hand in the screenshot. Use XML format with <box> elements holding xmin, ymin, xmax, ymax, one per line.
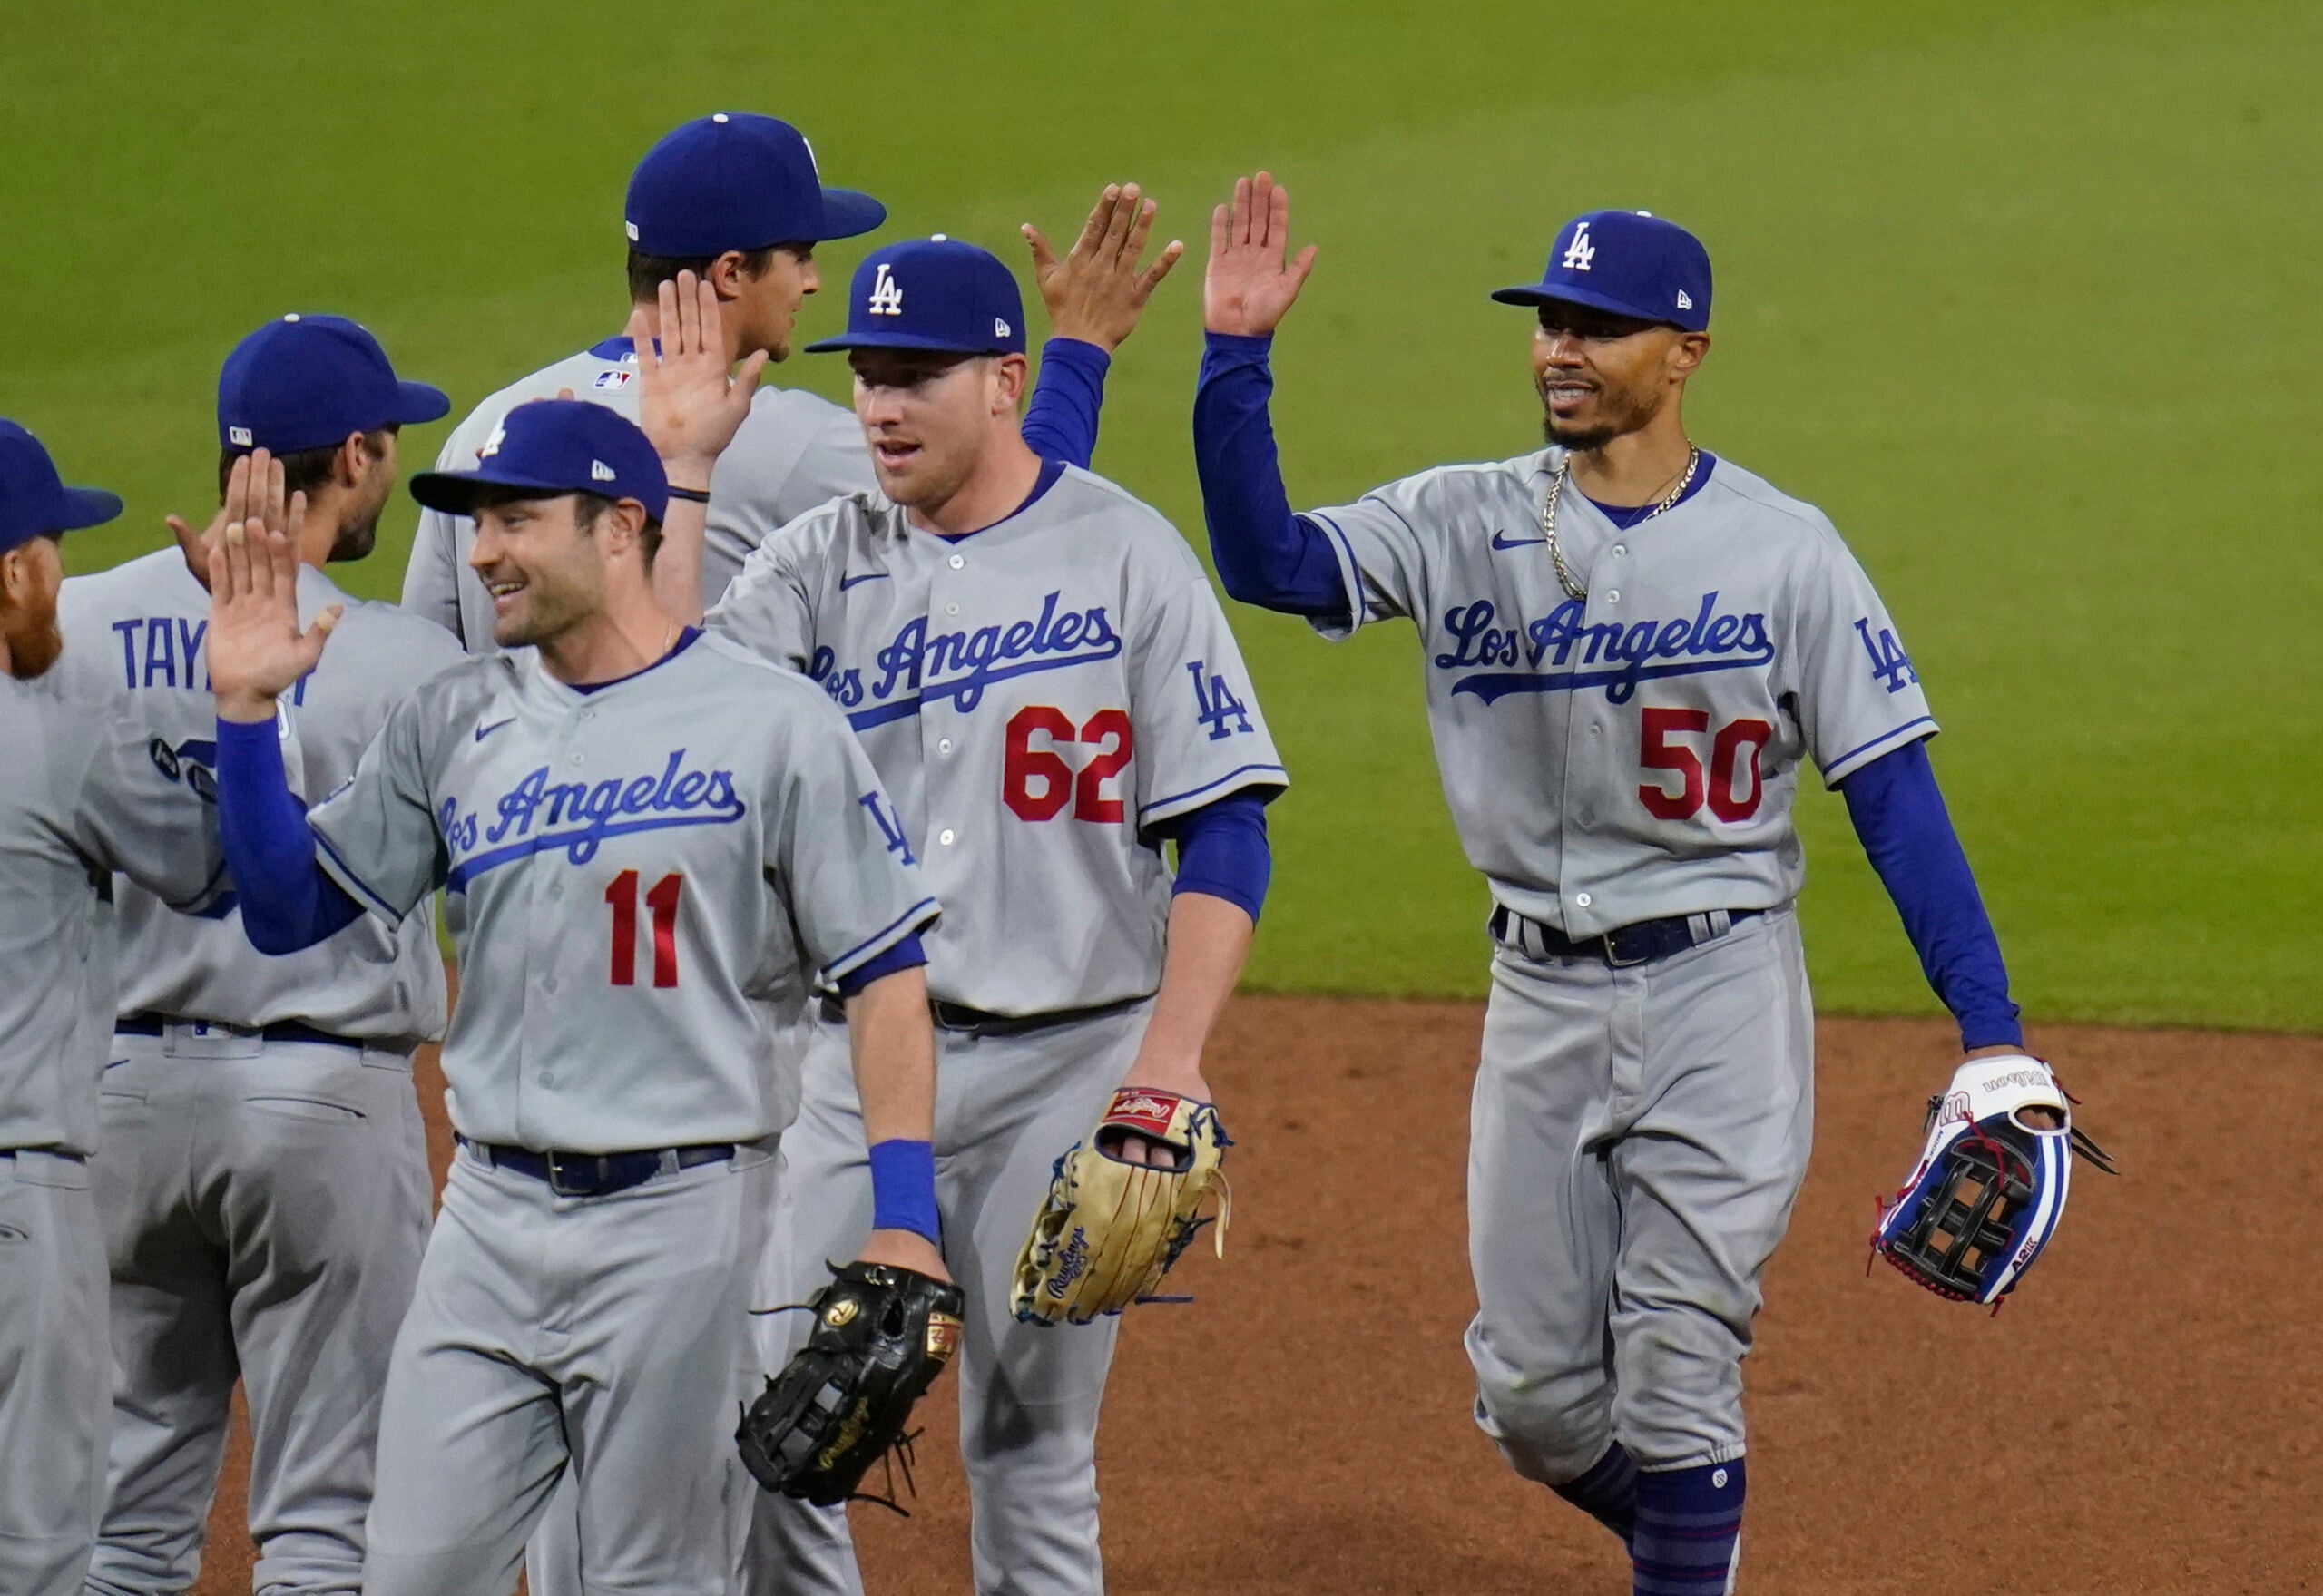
<box><xmin>1872</xmin><ymin>1054</ymin><xmax>2121</xmax><ymax>1303</ymax></box>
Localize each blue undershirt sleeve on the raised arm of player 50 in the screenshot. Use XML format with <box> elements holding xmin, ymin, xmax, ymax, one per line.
<box><xmin>1194</xmin><ymin>332</ymin><xmax>1349</xmax><ymax>622</ymax></box>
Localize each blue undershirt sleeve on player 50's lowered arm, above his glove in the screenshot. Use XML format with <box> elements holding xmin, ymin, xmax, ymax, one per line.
<box><xmin>1840</xmin><ymin>739</ymin><xmax>2025</xmax><ymax>1048</ymax></box>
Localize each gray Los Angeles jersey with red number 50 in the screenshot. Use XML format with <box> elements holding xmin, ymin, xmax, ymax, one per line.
<box><xmin>1308</xmin><ymin>448</ymin><xmax>1935</xmax><ymax>936</ymax></box>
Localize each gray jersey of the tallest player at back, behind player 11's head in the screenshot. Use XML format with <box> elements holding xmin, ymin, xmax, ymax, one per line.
<box><xmin>404</xmin><ymin>337</ymin><xmax>876</xmax><ymax>652</ymax></box>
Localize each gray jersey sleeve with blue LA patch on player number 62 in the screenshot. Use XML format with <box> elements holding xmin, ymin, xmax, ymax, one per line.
<box><xmin>1124</xmin><ymin>560</ymin><xmax>1289</xmax><ymax>832</ymax></box>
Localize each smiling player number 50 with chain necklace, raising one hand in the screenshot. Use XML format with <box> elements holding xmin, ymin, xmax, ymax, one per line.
<box><xmin>1194</xmin><ymin>171</ymin><xmax>2024</xmax><ymax>1596</ymax></box>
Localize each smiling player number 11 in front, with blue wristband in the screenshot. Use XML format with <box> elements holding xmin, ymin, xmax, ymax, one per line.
<box><xmin>209</xmin><ymin>390</ymin><xmax>943</xmax><ymax>1596</ymax></box>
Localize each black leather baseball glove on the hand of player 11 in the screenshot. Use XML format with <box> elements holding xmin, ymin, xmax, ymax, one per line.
<box><xmin>734</xmin><ymin>1264</ymin><xmax>966</xmax><ymax>1510</ymax></box>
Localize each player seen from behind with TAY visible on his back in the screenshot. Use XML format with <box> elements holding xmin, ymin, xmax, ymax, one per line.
<box><xmin>61</xmin><ymin>316</ymin><xmax>462</xmax><ymax>1596</ymax></box>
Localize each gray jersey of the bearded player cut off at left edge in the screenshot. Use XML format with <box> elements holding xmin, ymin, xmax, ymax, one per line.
<box><xmin>0</xmin><ymin>671</ymin><xmax>225</xmax><ymax>1157</ymax></box>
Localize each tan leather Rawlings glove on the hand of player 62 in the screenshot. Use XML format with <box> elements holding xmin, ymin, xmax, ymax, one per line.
<box><xmin>1011</xmin><ymin>1087</ymin><xmax>1231</xmax><ymax>1324</ymax></box>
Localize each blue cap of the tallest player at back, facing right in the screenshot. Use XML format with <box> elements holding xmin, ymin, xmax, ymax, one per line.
<box><xmin>622</xmin><ymin>112</ymin><xmax>887</xmax><ymax>260</ymax></box>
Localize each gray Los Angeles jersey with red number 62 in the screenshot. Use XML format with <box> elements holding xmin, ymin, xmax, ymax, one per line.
<box><xmin>709</xmin><ymin>467</ymin><xmax>1287</xmax><ymax>1015</ymax></box>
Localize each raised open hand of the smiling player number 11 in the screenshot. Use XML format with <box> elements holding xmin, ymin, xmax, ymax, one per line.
<box><xmin>202</xmin><ymin>496</ymin><xmax>339</xmax><ymax>720</ymax></box>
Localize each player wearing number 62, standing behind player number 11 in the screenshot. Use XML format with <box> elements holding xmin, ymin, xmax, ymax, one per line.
<box><xmin>660</xmin><ymin>237</ymin><xmax>1285</xmax><ymax>1596</ymax></box>
